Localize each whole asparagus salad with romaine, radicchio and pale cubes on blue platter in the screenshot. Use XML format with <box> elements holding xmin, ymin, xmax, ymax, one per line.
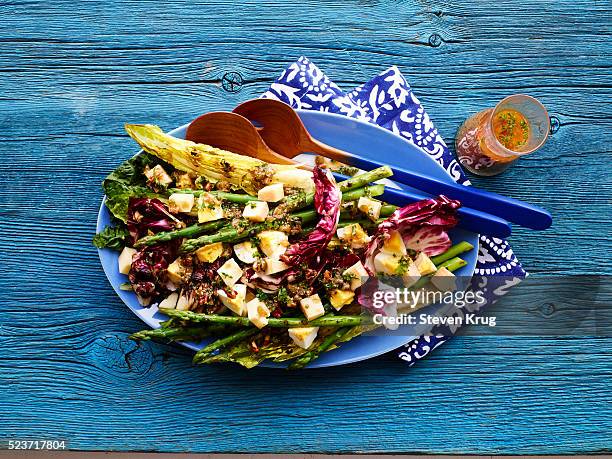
<box><xmin>94</xmin><ymin>125</ymin><xmax>473</xmax><ymax>368</ymax></box>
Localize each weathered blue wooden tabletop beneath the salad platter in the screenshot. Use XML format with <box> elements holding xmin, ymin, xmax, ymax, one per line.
<box><xmin>0</xmin><ymin>0</ymin><xmax>612</xmax><ymax>454</ymax></box>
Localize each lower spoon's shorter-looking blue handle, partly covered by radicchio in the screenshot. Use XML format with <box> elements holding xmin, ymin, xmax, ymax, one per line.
<box><xmin>381</xmin><ymin>187</ymin><xmax>512</xmax><ymax>239</ymax></box>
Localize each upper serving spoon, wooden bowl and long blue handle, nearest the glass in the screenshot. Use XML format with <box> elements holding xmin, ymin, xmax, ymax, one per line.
<box><xmin>234</xmin><ymin>99</ymin><xmax>552</xmax><ymax>231</ymax></box>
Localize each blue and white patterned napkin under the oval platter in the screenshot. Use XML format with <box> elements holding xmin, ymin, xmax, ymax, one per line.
<box><xmin>262</xmin><ymin>57</ymin><xmax>527</xmax><ymax>365</ymax></box>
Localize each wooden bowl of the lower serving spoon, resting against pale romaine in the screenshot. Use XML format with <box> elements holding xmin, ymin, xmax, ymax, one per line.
<box><xmin>185</xmin><ymin>112</ymin><xmax>296</xmax><ymax>164</ymax></box>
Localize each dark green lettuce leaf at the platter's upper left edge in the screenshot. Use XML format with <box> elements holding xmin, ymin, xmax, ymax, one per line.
<box><xmin>102</xmin><ymin>152</ymin><xmax>166</xmax><ymax>223</ymax></box>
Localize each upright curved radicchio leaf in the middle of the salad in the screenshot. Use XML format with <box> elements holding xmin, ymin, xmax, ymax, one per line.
<box><xmin>281</xmin><ymin>167</ymin><xmax>342</xmax><ymax>267</ymax></box>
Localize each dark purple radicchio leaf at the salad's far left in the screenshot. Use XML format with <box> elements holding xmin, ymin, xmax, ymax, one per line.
<box><xmin>127</xmin><ymin>198</ymin><xmax>175</xmax><ymax>243</ymax></box>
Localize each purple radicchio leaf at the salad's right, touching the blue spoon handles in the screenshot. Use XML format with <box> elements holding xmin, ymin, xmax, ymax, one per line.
<box><xmin>364</xmin><ymin>195</ymin><xmax>461</xmax><ymax>273</ymax></box>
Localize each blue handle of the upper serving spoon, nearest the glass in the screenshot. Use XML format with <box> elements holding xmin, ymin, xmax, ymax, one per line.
<box><xmin>342</xmin><ymin>154</ymin><xmax>552</xmax><ymax>233</ymax></box>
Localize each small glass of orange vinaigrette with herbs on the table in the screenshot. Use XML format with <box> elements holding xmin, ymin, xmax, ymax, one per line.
<box><xmin>455</xmin><ymin>94</ymin><xmax>550</xmax><ymax>175</ymax></box>
